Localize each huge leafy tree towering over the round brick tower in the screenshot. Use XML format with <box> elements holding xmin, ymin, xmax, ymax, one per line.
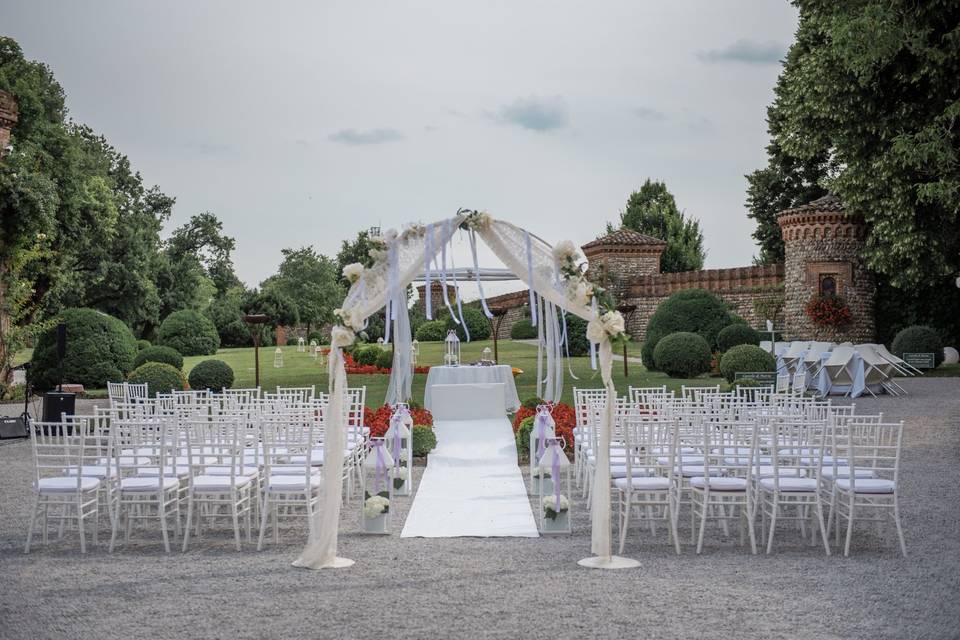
<box><xmin>748</xmin><ymin>0</ymin><xmax>960</xmax><ymax>336</ymax></box>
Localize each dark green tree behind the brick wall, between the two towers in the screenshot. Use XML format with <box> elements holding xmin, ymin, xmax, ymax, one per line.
<box><xmin>607</xmin><ymin>178</ymin><xmax>706</xmax><ymax>273</ymax></box>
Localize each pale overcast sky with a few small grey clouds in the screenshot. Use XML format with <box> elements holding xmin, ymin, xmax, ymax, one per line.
<box><xmin>0</xmin><ymin>0</ymin><xmax>797</xmax><ymax>298</ymax></box>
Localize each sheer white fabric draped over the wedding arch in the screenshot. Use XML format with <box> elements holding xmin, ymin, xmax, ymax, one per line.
<box><xmin>294</xmin><ymin>214</ymin><xmax>616</xmax><ymax>568</ymax></box>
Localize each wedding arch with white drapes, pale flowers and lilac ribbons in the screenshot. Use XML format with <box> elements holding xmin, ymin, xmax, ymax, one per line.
<box><xmin>293</xmin><ymin>209</ymin><xmax>636</xmax><ymax>569</ymax></box>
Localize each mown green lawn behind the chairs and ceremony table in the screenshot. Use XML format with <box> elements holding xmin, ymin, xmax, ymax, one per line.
<box><xmin>183</xmin><ymin>340</ymin><xmax>721</xmax><ymax>407</ymax></box>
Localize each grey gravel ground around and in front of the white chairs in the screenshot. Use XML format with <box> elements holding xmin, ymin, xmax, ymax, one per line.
<box><xmin>0</xmin><ymin>378</ymin><xmax>960</xmax><ymax>639</ymax></box>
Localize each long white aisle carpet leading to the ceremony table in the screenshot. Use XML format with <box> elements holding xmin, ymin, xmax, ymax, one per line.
<box><xmin>400</xmin><ymin>417</ymin><xmax>539</xmax><ymax>538</ymax></box>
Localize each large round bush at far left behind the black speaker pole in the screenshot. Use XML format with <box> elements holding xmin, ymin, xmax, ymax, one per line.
<box><xmin>30</xmin><ymin>309</ymin><xmax>137</xmax><ymax>390</ymax></box>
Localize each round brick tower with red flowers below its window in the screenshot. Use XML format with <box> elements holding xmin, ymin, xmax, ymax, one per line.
<box><xmin>777</xmin><ymin>195</ymin><xmax>876</xmax><ymax>343</ymax></box>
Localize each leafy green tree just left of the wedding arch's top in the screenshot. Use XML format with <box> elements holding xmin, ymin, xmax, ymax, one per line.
<box><xmin>260</xmin><ymin>247</ymin><xmax>346</xmax><ymax>327</ymax></box>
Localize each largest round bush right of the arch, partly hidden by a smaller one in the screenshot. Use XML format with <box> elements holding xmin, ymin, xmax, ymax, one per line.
<box><xmin>641</xmin><ymin>289</ymin><xmax>732</xmax><ymax>369</ymax></box>
